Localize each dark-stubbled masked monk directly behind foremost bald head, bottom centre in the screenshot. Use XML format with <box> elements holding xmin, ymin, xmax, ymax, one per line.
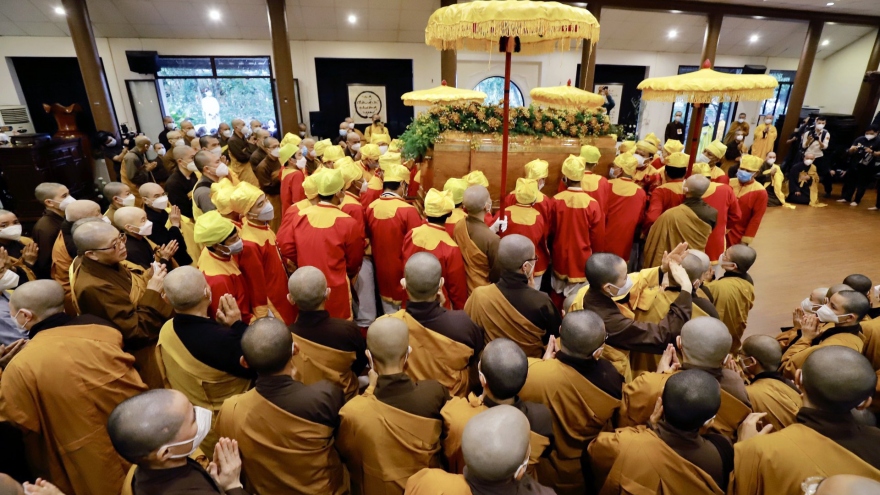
<box><xmin>440</xmin><ymin>338</ymin><xmax>553</xmax><ymax>478</ymax></box>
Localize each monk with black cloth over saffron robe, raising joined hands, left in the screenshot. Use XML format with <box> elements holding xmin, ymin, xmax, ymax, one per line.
<box><xmin>156</xmin><ymin>266</ymin><xmax>256</xmax><ymax>458</ymax></box>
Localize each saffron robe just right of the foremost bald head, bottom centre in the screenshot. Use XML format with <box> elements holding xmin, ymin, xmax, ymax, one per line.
<box><xmin>519</xmin><ymin>359</ymin><xmax>620</xmax><ymax>495</ymax></box>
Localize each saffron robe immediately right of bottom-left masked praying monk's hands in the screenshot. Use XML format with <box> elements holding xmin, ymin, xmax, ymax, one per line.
<box><xmin>215</xmin><ymin>390</ymin><xmax>348</xmax><ymax>495</ymax></box>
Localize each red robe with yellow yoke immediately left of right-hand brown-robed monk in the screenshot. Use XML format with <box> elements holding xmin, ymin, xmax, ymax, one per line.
<box><xmin>605</xmin><ymin>177</ymin><xmax>648</xmax><ymax>261</ymax></box>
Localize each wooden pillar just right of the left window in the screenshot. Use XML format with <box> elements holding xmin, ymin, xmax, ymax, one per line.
<box><xmin>266</xmin><ymin>0</ymin><xmax>299</xmax><ymax>136</ymax></box>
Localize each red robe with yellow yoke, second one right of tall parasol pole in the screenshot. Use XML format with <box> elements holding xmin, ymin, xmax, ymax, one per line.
<box><xmin>551</xmin><ymin>188</ymin><xmax>605</xmax><ymax>284</ymax></box>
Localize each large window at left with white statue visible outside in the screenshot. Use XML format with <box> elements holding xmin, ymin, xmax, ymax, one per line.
<box><xmin>156</xmin><ymin>57</ymin><xmax>277</xmax><ymax>135</ymax></box>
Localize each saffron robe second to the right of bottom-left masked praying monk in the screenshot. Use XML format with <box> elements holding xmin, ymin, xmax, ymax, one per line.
<box><xmin>336</xmin><ymin>387</ymin><xmax>443</xmax><ymax>495</ymax></box>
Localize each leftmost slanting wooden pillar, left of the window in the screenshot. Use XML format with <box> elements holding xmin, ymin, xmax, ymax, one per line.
<box><xmin>60</xmin><ymin>0</ymin><xmax>119</xmax><ymax>138</ymax></box>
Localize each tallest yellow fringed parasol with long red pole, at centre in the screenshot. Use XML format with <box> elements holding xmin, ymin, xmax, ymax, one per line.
<box><xmin>425</xmin><ymin>0</ymin><xmax>599</xmax><ymax>216</ymax></box>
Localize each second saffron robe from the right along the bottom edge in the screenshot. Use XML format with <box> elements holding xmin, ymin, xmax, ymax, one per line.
<box><xmin>589</xmin><ymin>426</ymin><xmax>725</xmax><ymax>495</ymax></box>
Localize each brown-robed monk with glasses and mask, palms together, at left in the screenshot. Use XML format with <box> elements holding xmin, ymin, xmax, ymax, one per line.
<box><xmin>70</xmin><ymin>222</ymin><xmax>171</xmax><ymax>388</ymax></box>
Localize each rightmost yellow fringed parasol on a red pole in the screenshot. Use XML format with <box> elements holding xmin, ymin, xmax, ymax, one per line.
<box><xmin>638</xmin><ymin>60</ymin><xmax>779</xmax><ymax>175</ymax></box>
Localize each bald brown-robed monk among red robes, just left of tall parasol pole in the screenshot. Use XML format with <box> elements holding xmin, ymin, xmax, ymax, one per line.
<box><xmin>452</xmin><ymin>184</ymin><xmax>500</xmax><ymax>294</ymax></box>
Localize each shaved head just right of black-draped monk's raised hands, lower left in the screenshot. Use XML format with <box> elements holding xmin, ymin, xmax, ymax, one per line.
<box><xmin>241</xmin><ymin>318</ymin><xmax>293</xmax><ymax>375</ymax></box>
